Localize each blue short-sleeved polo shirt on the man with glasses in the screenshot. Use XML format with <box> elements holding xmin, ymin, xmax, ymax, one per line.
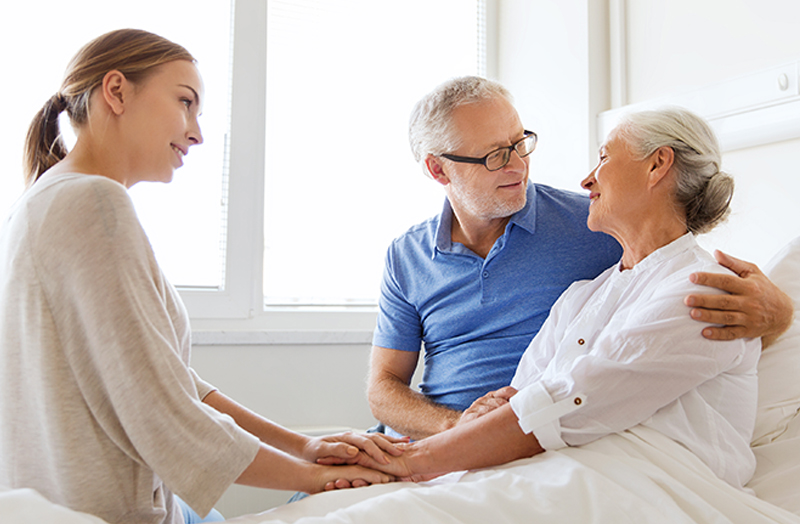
<box><xmin>372</xmin><ymin>184</ymin><xmax>622</xmax><ymax>410</ymax></box>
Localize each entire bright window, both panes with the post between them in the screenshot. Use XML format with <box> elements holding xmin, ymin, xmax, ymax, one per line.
<box><xmin>0</xmin><ymin>0</ymin><xmax>486</xmax><ymax>318</ymax></box>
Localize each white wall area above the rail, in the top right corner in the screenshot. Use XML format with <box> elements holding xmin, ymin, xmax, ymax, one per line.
<box><xmin>626</xmin><ymin>0</ymin><xmax>800</xmax><ymax>103</ymax></box>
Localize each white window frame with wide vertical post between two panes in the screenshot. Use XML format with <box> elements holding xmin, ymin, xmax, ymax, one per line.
<box><xmin>183</xmin><ymin>0</ymin><xmax>497</xmax><ymax>330</ymax></box>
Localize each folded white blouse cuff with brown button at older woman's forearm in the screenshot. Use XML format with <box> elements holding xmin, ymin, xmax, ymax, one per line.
<box><xmin>510</xmin><ymin>382</ymin><xmax>586</xmax><ymax>451</ymax></box>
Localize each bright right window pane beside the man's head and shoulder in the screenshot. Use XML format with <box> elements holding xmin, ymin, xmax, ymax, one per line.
<box><xmin>264</xmin><ymin>0</ymin><xmax>485</xmax><ymax>305</ymax></box>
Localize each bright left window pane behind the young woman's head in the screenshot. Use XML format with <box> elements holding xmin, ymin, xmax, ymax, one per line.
<box><xmin>0</xmin><ymin>0</ymin><xmax>231</xmax><ymax>288</ymax></box>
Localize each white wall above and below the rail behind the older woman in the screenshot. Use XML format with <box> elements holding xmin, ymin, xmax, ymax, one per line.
<box><xmin>626</xmin><ymin>0</ymin><xmax>800</xmax><ymax>266</ymax></box>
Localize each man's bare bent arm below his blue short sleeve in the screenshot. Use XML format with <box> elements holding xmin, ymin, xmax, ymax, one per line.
<box><xmin>367</xmin><ymin>346</ymin><xmax>461</xmax><ymax>440</ymax></box>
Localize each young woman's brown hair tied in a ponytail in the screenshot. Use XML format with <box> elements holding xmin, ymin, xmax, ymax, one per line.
<box><xmin>24</xmin><ymin>29</ymin><xmax>195</xmax><ymax>186</ymax></box>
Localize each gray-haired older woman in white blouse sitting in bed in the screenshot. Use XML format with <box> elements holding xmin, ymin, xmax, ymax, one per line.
<box><xmin>358</xmin><ymin>109</ymin><xmax>760</xmax><ymax>487</ymax></box>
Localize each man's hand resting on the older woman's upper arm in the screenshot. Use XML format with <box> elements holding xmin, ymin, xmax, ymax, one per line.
<box><xmin>685</xmin><ymin>251</ymin><xmax>794</xmax><ymax>348</ymax></box>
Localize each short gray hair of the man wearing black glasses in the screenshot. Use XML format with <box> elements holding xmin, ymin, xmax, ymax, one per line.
<box><xmin>408</xmin><ymin>76</ymin><xmax>511</xmax><ymax>172</ymax></box>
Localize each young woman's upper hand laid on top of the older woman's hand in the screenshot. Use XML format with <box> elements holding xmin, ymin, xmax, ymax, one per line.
<box><xmin>303</xmin><ymin>432</ymin><xmax>408</xmax><ymax>465</ymax></box>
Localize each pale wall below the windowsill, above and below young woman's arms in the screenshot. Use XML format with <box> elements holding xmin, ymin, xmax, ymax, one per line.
<box><xmin>192</xmin><ymin>344</ymin><xmax>375</xmax><ymax>518</ymax></box>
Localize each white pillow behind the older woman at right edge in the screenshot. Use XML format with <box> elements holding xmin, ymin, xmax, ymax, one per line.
<box><xmin>752</xmin><ymin>237</ymin><xmax>800</xmax><ymax>446</ymax></box>
